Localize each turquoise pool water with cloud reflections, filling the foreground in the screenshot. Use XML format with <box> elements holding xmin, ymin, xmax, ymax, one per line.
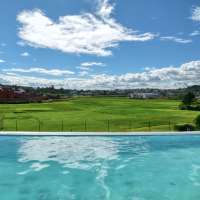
<box><xmin>0</xmin><ymin>136</ymin><xmax>200</xmax><ymax>200</ymax></box>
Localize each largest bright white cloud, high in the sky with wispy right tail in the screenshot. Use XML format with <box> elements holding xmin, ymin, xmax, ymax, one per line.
<box><xmin>17</xmin><ymin>0</ymin><xmax>157</xmax><ymax>56</ymax></box>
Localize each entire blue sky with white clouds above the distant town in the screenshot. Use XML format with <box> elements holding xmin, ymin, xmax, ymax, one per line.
<box><xmin>0</xmin><ymin>0</ymin><xmax>200</xmax><ymax>89</ymax></box>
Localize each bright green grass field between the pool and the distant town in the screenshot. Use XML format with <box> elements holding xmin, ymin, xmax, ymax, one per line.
<box><xmin>0</xmin><ymin>98</ymin><xmax>199</xmax><ymax>132</ymax></box>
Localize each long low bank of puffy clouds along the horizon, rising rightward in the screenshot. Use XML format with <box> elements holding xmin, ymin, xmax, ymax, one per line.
<box><xmin>0</xmin><ymin>61</ymin><xmax>200</xmax><ymax>89</ymax></box>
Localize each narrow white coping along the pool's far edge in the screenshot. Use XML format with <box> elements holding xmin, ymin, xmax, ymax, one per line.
<box><xmin>0</xmin><ymin>131</ymin><xmax>200</xmax><ymax>136</ymax></box>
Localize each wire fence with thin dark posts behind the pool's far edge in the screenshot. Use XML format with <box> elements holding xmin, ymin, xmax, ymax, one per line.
<box><xmin>0</xmin><ymin>119</ymin><xmax>177</xmax><ymax>132</ymax></box>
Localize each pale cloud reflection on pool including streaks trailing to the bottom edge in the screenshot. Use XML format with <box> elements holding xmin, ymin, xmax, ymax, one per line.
<box><xmin>18</xmin><ymin>137</ymin><xmax>149</xmax><ymax>199</ymax></box>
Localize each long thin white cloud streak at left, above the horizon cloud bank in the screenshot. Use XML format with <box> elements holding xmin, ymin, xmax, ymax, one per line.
<box><xmin>3</xmin><ymin>68</ymin><xmax>74</xmax><ymax>76</ymax></box>
